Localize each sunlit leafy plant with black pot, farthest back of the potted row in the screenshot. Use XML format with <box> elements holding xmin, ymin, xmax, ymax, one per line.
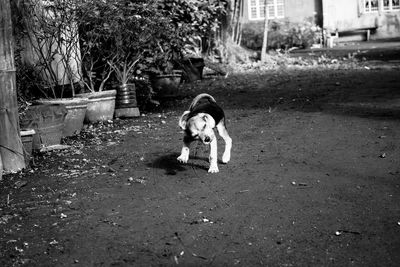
<box><xmin>152</xmin><ymin>0</ymin><xmax>228</xmax><ymax>86</ymax></box>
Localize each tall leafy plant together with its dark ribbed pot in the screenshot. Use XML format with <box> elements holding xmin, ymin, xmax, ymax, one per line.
<box><xmin>81</xmin><ymin>0</ymin><xmax>167</xmax><ymax>117</ymax></box>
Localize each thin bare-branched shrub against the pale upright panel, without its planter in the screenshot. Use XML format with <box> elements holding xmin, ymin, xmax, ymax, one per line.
<box><xmin>20</xmin><ymin>0</ymin><xmax>81</xmax><ymax>98</ymax></box>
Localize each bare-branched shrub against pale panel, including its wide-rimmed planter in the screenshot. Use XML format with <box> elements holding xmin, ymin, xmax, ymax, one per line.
<box><xmin>19</xmin><ymin>0</ymin><xmax>88</xmax><ymax>136</ymax></box>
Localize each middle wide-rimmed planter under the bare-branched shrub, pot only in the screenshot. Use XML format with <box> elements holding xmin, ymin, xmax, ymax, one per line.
<box><xmin>37</xmin><ymin>97</ymin><xmax>88</xmax><ymax>137</ymax></box>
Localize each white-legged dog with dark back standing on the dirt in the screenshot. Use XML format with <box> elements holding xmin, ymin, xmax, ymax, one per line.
<box><xmin>177</xmin><ymin>93</ymin><xmax>232</xmax><ymax>173</ymax></box>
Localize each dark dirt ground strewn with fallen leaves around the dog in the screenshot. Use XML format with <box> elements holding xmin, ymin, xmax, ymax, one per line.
<box><xmin>0</xmin><ymin>40</ymin><xmax>400</xmax><ymax>266</ymax></box>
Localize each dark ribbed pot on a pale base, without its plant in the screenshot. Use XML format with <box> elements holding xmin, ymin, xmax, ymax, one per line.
<box><xmin>115</xmin><ymin>83</ymin><xmax>140</xmax><ymax>118</ymax></box>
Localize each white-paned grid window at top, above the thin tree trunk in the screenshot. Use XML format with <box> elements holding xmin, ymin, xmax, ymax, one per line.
<box><xmin>249</xmin><ymin>0</ymin><xmax>285</xmax><ymax>20</ymax></box>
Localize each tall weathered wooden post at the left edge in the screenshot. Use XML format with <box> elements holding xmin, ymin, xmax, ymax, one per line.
<box><xmin>0</xmin><ymin>0</ymin><xmax>25</xmax><ymax>176</ymax></box>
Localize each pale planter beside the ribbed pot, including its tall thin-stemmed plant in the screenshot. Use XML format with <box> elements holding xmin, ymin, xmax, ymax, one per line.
<box><xmin>75</xmin><ymin>0</ymin><xmax>117</xmax><ymax>123</ymax></box>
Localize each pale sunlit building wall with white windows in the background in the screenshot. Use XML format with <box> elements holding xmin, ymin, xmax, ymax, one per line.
<box><xmin>242</xmin><ymin>0</ymin><xmax>400</xmax><ymax>40</ymax></box>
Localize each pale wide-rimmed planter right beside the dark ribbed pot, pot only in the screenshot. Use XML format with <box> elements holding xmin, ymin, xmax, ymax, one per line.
<box><xmin>76</xmin><ymin>90</ymin><xmax>117</xmax><ymax>123</ymax></box>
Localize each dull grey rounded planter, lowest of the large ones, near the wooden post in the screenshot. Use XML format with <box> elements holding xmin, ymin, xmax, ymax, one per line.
<box><xmin>20</xmin><ymin>104</ymin><xmax>67</xmax><ymax>150</ymax></box>
